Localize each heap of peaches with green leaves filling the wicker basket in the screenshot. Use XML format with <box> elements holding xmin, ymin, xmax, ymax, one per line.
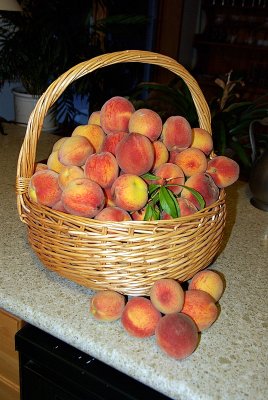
<box><xmin>28</xmin><ymin>96</ymin><xmax>239</xmax><ymax>222</ymax></box>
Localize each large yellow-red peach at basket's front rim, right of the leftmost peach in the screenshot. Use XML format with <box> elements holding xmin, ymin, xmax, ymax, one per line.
<box><xmin>61</xmin><ymin>178</ymin><xmax>105</xmax><ymax>218</ymax></box>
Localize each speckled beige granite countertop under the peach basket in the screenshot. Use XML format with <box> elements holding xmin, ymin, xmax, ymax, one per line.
<box><xmin>0</xmin><ymin>124</ymin><xmax>268</xmax><ymax>400</ymax></box>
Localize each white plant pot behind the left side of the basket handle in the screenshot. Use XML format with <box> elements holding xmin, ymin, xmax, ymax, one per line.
<box><xmin>12</xmin><ymin>88</ymin><xmax>57</xmax><ymax>131</ymax></box>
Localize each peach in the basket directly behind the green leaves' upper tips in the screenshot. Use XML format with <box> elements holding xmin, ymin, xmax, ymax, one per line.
<box><xmin>154</xmin><ymin>163</ymin><xmax>185</xmax><ymax>194</ymax></box>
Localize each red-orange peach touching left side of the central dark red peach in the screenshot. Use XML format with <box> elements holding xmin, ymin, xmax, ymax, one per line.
<box><xmin>84</xmin><ymin>151</ymin><xmax>119</xmax><ymax>188</ymax></box>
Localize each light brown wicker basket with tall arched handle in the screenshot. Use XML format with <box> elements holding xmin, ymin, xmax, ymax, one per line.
<box><xmin>16</xmin><ymin>50</ymin><xmax>226</xmax><ymax>296</ymax></box>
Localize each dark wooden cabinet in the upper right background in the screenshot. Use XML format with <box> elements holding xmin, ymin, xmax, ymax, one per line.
<box><xmin>194</xmin><ymin>0</ymin><xmax>268</xmax><ymax>98</ymax></box>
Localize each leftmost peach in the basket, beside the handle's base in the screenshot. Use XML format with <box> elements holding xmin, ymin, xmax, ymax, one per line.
<box><xmin>28</xmin><ymin>169</ymin><xmax>62</xmax><ymax>207</ymax></box>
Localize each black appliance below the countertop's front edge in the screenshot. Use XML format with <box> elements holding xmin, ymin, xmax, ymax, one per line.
<box><xmin>15</xmin><ymin>324</ymin><xmax>169</xmax><ymax>400</ymax></box>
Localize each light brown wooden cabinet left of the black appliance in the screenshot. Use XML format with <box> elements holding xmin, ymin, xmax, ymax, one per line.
<box><xmin>0</xmin><ymin>309</ymin><xmax>24</xmax><ymax>400</ymax></box>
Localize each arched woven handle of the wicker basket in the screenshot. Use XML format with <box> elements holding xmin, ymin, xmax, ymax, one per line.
<box><xmin>16</xmin><ymin>50</ymin><xmax>211</xmax><ymax>219</ymax></box>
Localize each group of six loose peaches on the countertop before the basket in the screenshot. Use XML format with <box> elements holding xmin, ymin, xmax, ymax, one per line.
<box><xmin>90</xmin><ymin>269</ymin><xmax>224</xmax><ymax>360</ymax></box>
